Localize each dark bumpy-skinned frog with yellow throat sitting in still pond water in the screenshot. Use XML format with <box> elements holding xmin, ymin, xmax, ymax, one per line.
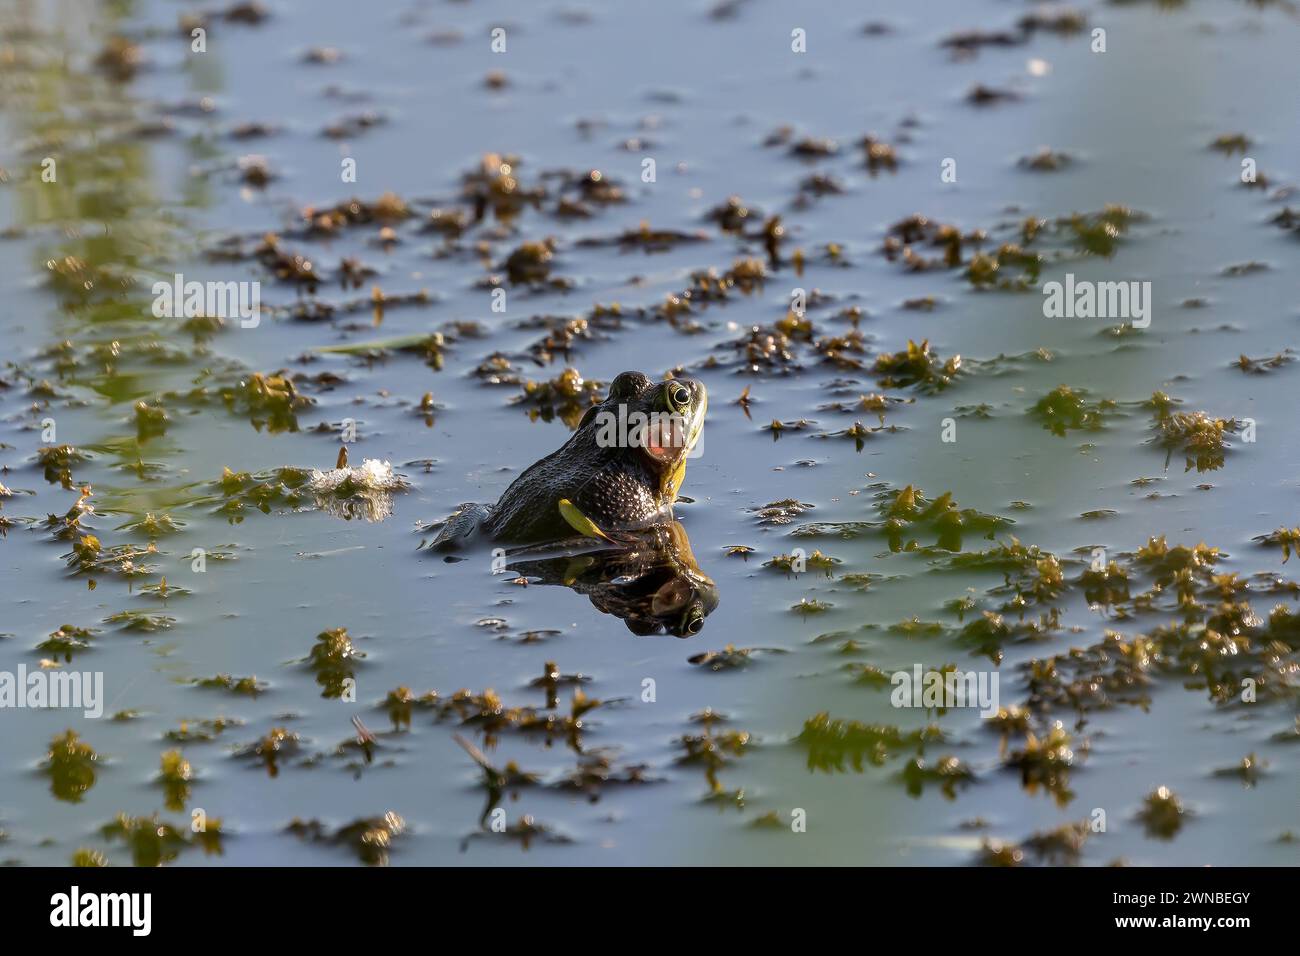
<box><xmin>432</xmin><ymin>372</ymin><xmax>709</xmax><ymax>551</ymax></box>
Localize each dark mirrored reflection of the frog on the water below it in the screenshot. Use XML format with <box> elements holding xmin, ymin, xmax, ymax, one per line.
<box><xmin>506</xmin><ymin>522</ymin><xmax>718</xmax><ymax>637</ymax></box>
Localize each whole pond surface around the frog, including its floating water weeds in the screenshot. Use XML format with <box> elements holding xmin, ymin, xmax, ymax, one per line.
<box><xmin>0</xmin><ymin>0</ymin><xmax>1300</xmax><ymax>865</ymax></box>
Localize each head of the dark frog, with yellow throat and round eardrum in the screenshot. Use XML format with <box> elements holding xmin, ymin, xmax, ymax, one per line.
<box><xmin>581</xmin><ymin>372</ymin><xmax>709</xmax><ymax>501</ymax></box>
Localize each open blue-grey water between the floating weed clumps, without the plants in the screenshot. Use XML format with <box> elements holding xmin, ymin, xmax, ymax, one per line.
<box><xmin>0</xmin><ymin>1</ymin><xmax>1300</xmax><ymax>865</ymax></box>
